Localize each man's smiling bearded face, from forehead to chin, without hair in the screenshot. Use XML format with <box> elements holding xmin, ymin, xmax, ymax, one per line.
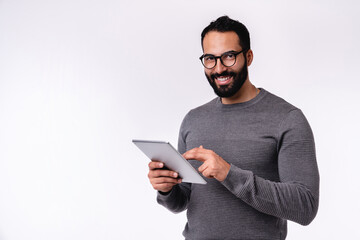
<box><xmin>203</xmin><ymin>31</ymin><xmax>248</xmax><ymax>98</ymax></box>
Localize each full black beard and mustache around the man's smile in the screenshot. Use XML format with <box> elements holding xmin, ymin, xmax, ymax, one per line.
<box><xmin>205</xmin><ymin>58</ymin><xmax>248</xmax><ymax>98</ymax></box>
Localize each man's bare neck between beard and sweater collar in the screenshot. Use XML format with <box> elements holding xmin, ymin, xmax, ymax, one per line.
<box><xmin>221</xmin><ymin>79</ymin><xmax>259</xmax><ymax>104</ymax></box>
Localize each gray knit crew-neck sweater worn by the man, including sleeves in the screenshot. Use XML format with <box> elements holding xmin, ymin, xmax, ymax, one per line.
<box><xmin>157</xmin><ymin>89</ymin><xmax>319</xmax><ymax>240</ymax></box>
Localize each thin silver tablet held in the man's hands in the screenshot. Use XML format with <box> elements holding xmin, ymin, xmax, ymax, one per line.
<box><xmin>132</xmin><ymin>140</ymin><xmax>206</xmax><ymax>184</ymax></box>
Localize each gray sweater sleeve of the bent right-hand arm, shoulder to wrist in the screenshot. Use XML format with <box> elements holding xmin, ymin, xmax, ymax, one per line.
<box><xmin>222</xmin><ymin>109</ymin><xmax>319</xmax><ymax>225</ymax></box>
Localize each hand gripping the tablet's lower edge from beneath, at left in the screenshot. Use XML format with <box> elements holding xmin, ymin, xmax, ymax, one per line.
<box><xmin>148</xmin><ymin>161</ymin><xmax>181</xmax><ymax>193</ymax></box>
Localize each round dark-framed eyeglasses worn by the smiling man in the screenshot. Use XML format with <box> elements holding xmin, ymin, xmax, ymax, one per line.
<box><xmin>199</xmin><ymin>50</ymin><xmax>244</xmax><ymax>69</ymax></box>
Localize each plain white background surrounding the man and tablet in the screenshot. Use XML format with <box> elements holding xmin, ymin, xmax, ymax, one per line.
<box><xmin>0</xmin><ymin>0</ymin><xmax>360</xmax><ymax>240</ymax></box>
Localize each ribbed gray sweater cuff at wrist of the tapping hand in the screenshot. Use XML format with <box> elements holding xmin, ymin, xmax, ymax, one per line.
<box><xmin>221</xmin><ymin>164</ymin><xmax>253</xmax><ymax>197</ymax></box>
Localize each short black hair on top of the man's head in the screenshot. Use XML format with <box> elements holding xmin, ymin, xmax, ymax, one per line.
<box><xmin>201</xmin><ymin>16</ymin><xmax>250</xmax><ymax>51</ymax></box>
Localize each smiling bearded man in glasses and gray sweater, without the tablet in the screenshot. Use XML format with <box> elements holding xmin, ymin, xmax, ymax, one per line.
<box><xmin>148</xmin><ymin>16</ymin><xmax>319</xmax><ymax>240</ymax></box>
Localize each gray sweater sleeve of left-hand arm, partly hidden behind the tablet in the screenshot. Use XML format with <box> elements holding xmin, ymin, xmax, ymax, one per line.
<box><xmin>157</xmin><ymin>115</ymin><xmax>191</xmax><ymax>213</ymax></box>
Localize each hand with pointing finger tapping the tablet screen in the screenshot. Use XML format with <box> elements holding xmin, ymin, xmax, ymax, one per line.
<box><xmin>183</xmin><ymin>146</ymin><xmax>230</xmax><ymax>182</ymax></box>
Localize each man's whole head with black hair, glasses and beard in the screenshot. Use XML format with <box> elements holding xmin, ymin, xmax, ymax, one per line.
<box><xmin>201</xmin><ymin>16</ymin><xmax>252</xmax><ymax>98</ymax></box>
